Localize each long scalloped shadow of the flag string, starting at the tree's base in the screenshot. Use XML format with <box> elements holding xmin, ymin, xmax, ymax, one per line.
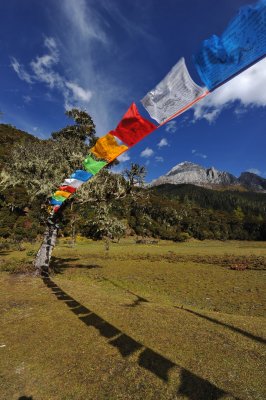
<box><xmin>43</xmin><ymin>278</ymin><xmax>236</xmax><ymax>400</ymax></box>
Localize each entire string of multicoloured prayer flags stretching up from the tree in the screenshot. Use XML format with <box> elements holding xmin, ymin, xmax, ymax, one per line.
<box><xmin>47</xmin><ymin>0</ymin><xmax>266</xmax><ymax>215</ymax></box>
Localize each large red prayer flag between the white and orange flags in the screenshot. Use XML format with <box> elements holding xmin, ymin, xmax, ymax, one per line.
<box><xmin>109</xmin><ymin>103</ymin><xmax>157</xmax><ymax>146</ymax></box>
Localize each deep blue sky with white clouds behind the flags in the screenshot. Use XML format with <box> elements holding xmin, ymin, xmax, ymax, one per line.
<box><xmin>0</xmin><ymin>0</ymin><xmax>266</xmax><ymax>181</ymax></box>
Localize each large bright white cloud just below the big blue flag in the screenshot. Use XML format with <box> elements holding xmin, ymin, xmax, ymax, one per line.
<box><xmin>194</xmin><ymin>58</ymin><xmax>266</xmax><ymax>123</ymax></box>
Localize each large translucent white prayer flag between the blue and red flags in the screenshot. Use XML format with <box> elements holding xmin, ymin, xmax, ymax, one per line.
<box><xmin>141</xmin><ymin>58</ymin><xmax>206</xmax><ymax>124</ymax></box>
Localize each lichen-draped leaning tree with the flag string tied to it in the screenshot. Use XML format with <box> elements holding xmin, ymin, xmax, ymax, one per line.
<box><xmin>0</xmin><ymin>109</ymin><xmax>149</xmax><ymax>276</ymax></box>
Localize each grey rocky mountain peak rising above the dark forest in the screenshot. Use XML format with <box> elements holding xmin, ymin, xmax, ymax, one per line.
<box><xmin>150</xmin><ymin>161</ymin><xmax>266</xmax><ymax>192</ymax></box>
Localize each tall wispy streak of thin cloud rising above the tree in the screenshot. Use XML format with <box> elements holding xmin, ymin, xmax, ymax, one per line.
<box><xmin>50</xmin><ymin>0</ymin><xmax>130</xmax><ymax>136</ymax></box>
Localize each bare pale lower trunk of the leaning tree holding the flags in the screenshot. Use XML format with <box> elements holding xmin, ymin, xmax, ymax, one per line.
<box><xmin>34</xmin><ymin>224</ymin><xmax>58</xmax><ymax>276</ymax></box>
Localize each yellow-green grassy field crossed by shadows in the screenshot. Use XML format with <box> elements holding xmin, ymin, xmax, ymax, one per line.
<box><xmin>0</xmin><ymin>239</ymin><xmax>266</xmax><ymax>400</ymax></box>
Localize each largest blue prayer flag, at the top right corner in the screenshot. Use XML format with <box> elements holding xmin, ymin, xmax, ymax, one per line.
<box><xmin>194</xmin><ymin>0</ymin><xmax>266</xmax><ymax>90</ymax></box>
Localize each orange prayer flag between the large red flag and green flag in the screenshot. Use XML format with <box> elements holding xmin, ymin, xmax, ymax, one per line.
<box><xmin>90</xmin><ymin>133</ymin><xmax>128</xmax><ymax>162</ymax></box>
